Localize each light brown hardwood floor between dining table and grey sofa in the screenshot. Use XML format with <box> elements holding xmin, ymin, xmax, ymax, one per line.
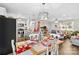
<box><xmin>59</xmin><ymin>39</ymin><xmax>79</xmax><ymax>55</ymax></box>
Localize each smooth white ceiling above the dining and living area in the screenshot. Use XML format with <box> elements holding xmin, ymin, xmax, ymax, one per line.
<box><xmin>0</xmin><ymin>3</ymin><xmax>79</xmax><ymax>18</ymax></box>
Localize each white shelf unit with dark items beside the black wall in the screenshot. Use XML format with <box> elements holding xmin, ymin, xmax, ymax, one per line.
<box><xmin>16</xmin><ymin>18</ymin><xmax>28</xmax><ymax>39</ymax></box>
